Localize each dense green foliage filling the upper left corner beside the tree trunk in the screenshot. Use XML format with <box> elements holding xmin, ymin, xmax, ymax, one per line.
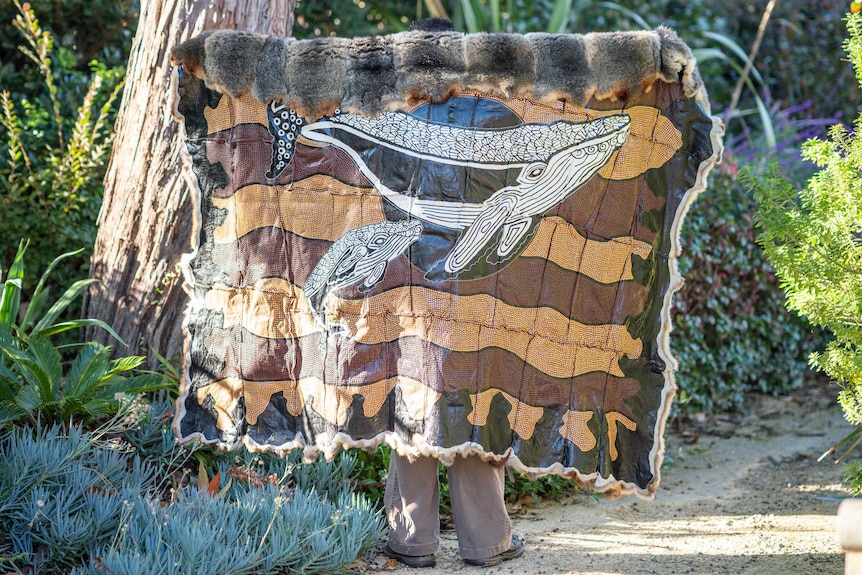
<box><xmin>0</xmin><ymin>0</ymin><xmax>133</xmax><ymax>283</ymax></box>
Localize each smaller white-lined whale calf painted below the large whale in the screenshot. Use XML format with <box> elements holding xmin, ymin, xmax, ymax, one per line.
<box><xmin>303</xmin><ymin>220</ymin><xmax>422</xmax><ymax>308</ymax></box>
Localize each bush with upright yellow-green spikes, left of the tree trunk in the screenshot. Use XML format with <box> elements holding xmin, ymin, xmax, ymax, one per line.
<box><xmin>0</xmin><ymin>0</ymin><xmax>124</xmax><ymax>292</ymax></box>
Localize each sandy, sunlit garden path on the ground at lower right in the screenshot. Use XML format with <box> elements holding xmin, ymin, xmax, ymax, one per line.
<box><xmin>367</xmin><ymin>383</ymin><xmax>862</xmax><ymax>575</ymax></box>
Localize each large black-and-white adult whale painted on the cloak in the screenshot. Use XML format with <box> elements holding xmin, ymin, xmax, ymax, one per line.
<box><xmin>267</xmin><ymin>104</ymin><xmax>631</xmax><ymax>273</ymax></box>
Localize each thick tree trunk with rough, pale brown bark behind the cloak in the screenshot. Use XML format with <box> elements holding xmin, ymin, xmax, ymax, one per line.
<box><xmin>82</xmin><ymin>0</ymin><xmax>295</xmax><ymax>369</ymax></box>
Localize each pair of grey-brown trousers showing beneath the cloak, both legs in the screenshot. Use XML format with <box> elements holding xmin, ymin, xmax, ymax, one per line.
<box><xmin>384</xmin><ymin>451</ymin><xmax>512</xmax><ymax>559</ymax></box>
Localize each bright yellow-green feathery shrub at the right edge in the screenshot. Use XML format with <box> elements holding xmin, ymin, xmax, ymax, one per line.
<box><xmin>746</xmin><ymin>14</ymin><xmax>862</xmax><ymax>486</ymax></box>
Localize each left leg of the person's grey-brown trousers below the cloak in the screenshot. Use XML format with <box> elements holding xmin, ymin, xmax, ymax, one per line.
<box><xmin>383</xmin><ymin>451</ymin><xmax>440</xmax><ymax>556</ymax></box>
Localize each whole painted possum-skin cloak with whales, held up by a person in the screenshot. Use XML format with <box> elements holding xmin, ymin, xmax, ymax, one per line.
<box><xmin>172</xmin><ymin>28</ymin><xmax>722</xmax><ymax>497</ymax></box>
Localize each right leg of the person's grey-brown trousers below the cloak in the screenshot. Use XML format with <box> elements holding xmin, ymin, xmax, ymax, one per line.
<box><xmin>448</xmin><ymin>456</ymin><xmax>512</xmax><ymax>560</ymax></box>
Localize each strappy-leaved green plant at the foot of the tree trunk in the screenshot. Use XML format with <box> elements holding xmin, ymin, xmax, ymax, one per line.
<box><xmin>0</xmin><ymin>242</ymin><xmax>165</xmax><ymax>428</ymax></box>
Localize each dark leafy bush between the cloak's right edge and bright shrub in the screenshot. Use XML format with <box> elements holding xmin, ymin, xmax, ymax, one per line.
<box><xmin>671</xmin><ymin>172</ymin><xmax>822</xmax><ymax>412</ymax></box>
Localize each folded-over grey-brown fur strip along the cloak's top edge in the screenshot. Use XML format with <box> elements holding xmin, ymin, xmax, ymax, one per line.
<box><xmin>172</xmin><ymin>27</ymin><xmax>703</xmax><ymax>118</ymax></box>
